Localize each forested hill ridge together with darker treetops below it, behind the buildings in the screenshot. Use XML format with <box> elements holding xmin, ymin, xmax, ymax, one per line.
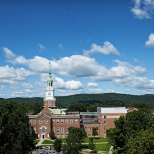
<box><xmin>0</xmin><ymin>93</ymin><xmax>154</xmax><ymax>114</ymax></box>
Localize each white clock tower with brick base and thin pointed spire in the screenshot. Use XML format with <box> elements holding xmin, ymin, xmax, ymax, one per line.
<box><xmin>44</xmin><ymin>62</ymin><xmax>56</xmax><ymax>108</ymax></box>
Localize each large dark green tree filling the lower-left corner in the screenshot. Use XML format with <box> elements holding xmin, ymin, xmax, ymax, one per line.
<box><xmin>0</xmin><ymin>102</ymin><xmax>35</xmax><ymax>154</ymax></box>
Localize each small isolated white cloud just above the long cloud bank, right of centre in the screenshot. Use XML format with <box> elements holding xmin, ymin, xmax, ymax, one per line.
<box><xmin>83</xmin><ymin>41</ymin><xmax>120</xmax><ymax>56</ymax></box>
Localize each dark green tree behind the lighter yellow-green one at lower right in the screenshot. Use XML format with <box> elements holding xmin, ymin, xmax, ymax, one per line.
<box><xmin>107</xmin><ymin>108</ymin><xmax>154</xmax><ymax>154</ymax></box>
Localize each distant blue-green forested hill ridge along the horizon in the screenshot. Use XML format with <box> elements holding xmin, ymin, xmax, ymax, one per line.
<box><xmin>0</xmin><ymin>93</ymin><xmax>154</xmax><ymax>106</ymax></box>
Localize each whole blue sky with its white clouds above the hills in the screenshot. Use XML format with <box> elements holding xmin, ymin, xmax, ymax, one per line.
<box><xmin>0</xmin><ymin>0</ymin><xmax>154</xmax><ymax>98</ymax></box>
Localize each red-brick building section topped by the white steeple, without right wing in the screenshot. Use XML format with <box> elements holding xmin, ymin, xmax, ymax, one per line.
<box><xmin>28</xmin><ymin>63</ymin><xmax>80</xmax><ymax>139</ymax></box>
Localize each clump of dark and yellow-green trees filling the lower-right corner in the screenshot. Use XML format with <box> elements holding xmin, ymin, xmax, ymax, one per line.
<box><xmin>107</xmin><ymin>108</ymin><xmax>154</xmax><ymax>154</ymax></box>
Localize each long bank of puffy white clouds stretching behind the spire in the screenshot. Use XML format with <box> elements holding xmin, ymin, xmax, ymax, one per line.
<box><xmin>0</xmin><ymin>47</ymin><xmax>154</xmax><ymax>93</ymax></box>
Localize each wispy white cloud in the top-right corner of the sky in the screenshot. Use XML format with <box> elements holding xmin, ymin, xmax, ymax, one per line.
<box><xmin>131</xmin><ymin>0</ymin><xmax>154</xmax><ymax>19</ymax></box>
